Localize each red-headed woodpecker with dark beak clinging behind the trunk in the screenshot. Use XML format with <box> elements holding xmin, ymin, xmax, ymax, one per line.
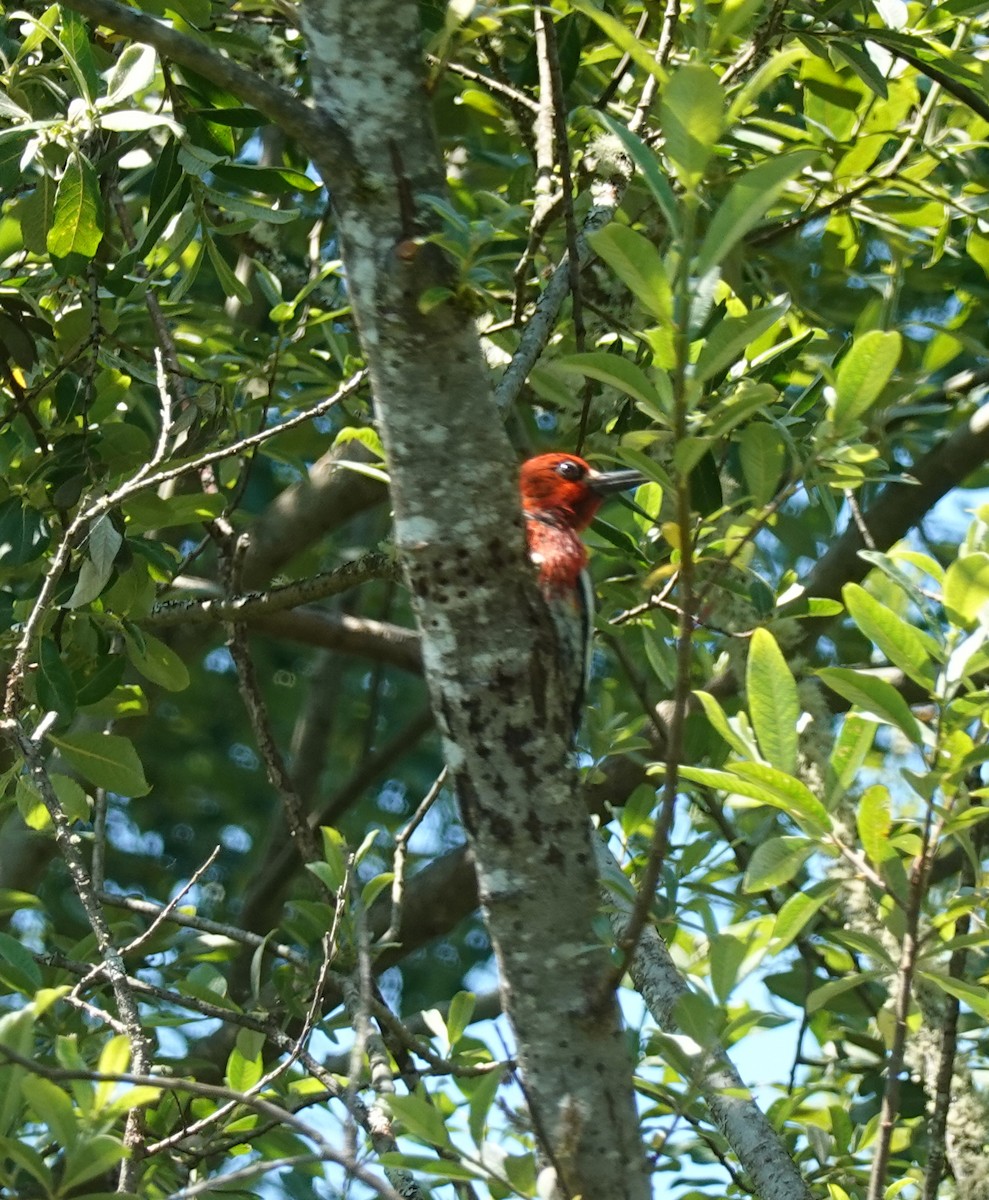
<box><xmin>519</xmin><ymin>454</ymin><xmax>645</xmax><ymax>734</ymax></box>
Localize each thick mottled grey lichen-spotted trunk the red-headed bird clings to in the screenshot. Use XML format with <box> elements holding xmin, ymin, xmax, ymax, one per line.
<box><xmin>304</xmin><ymin>0</ymin><xmax>648</xmax><ymax>1200</ymax></box>
